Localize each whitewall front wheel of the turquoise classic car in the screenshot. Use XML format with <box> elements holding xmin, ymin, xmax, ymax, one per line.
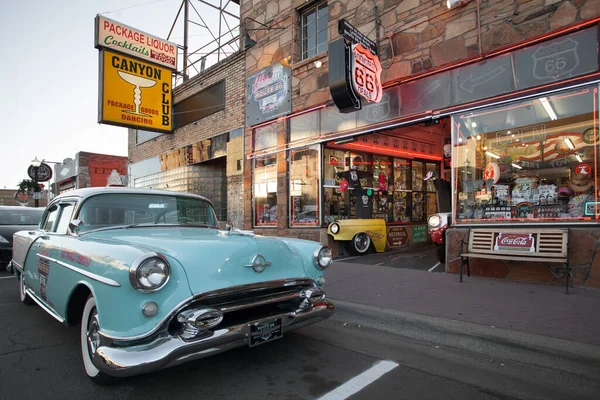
<box><xmin>81</xmin><ymin>295</ymin><xmax>113</xmax><ymax>385</ymax></box>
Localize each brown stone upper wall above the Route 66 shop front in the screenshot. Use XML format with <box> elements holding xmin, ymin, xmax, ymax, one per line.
<box><xmin>241</xmin><ymin>0</ymin><xmax>600</xmax><ymax>111</ymax></box>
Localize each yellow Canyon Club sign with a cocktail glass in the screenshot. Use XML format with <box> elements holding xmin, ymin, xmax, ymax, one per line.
<box><xmin>98</xmin><ymin>50</ymin><xmax>173</xmax><ymax>133</ymax></box>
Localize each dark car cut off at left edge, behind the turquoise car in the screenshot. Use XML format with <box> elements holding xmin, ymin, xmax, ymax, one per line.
<box><xmin>0</xmin><ymin>206</ymin><xmax>44</xmax><ymax>267</ymax></box>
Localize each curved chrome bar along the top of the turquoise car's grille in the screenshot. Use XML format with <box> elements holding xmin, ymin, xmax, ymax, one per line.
<box><xmin>99</xmin><ymin>278</ymin><xmax>317</xmax><ymax>341</ymax></box>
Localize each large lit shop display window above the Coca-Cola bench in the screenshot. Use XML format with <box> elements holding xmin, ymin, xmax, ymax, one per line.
<box><xmin>452</xmin><ymin>86</ymin><xmax>600</xmax><ymax>223</ymax></box>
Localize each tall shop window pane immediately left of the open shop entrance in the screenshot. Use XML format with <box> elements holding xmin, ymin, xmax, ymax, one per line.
<box><xmin>290</xmin><ymin>148</ymin><xmax>321</xmax><ymax>226</ymax></box>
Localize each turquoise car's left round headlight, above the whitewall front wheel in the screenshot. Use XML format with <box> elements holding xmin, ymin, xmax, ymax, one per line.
<box><xmin>129</xmin><ymin>253</ymin><xmax>171</xmax><ymax>292</ymax></box>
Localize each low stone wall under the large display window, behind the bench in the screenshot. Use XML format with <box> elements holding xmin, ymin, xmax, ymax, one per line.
<box><xmin>446</xmin><ymin>227</ymin><xmax>600</xmax><ymax>288</ymax></box>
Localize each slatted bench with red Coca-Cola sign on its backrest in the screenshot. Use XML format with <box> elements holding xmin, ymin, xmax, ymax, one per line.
<box><xmin>460</xmin><ymin>227</ymin><xmax>571</xmax><ymax>293</ymax></box>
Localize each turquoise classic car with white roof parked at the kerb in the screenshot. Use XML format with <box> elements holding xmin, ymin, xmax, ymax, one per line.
<box><xmin>8</xmin><ymin>187</ymin><xmax>334</xmax><ymax>383</ymax></box>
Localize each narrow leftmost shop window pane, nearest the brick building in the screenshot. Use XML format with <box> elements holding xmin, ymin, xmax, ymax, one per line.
<box><xmin>253</xmin><ymin>155</ymin><xmax>277</xmax><ymax>226</ymax></box>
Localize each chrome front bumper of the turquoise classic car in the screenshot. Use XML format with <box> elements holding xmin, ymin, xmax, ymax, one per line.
<box><xmin>92</xmin><ymin>300</ymin><xmax>335</xmax><ymax>377</ymax></box>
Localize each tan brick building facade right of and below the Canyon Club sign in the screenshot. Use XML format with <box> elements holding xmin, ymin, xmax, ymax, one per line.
<box><xmin>129</xmin><ymin>52</ymin><xmax>245</xmax><ymax>227</ymax></box>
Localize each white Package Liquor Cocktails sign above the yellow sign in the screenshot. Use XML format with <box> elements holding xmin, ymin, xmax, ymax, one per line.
<box><xmin>95</xmin><ymin>15</ymin><xmax>177</xmax><ymax>70</ymax></box>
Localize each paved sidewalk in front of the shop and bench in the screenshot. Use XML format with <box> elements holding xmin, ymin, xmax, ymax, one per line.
<box><xmin>325</xmin><ymin>261</ymin><xmax>600</xmax><ymax>351</ymax></box>
